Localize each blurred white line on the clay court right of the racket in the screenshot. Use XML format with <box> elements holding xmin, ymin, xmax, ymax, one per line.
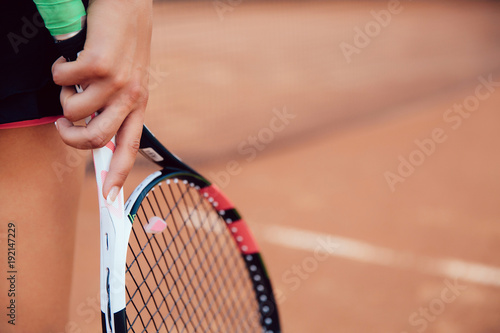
<box><xmin>257</xmin><ymin>225</ymin><xmax>500</xmax><ymax>287</ymax></box>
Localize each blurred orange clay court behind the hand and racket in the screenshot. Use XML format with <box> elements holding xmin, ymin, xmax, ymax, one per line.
<box><xmin>72</xmin><ymin>0</ymin><xmax>500</xmax><ymax>333</ymax></box>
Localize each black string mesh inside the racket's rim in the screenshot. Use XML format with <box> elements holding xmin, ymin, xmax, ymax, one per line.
<box><xmin>127</xmin><ymin>182</ymin><xmax>262</xmax><ymax>333</ymax></box>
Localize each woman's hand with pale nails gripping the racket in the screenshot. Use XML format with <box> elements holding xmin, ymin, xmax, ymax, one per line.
<box><xmin>52</xmin><ymin>0</ymin><xmax>152</xmax><ymax>201</ymax></box>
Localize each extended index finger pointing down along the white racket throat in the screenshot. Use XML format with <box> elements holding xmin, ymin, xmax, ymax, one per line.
<box><xmin>102</xmin><ymin>110</ymin><xmax>144</xmax><ymax>203</ymax></box>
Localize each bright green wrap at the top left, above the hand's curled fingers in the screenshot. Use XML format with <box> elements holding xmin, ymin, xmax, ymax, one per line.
<box><xmin>33</xmin><ymin>0</ymin><xmax>86</xmax><ymax>36</ymax></box>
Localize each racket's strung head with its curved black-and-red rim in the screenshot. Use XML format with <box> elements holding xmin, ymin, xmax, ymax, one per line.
<box><xmin>125</xmin><ymin>168</ymin><xmax>281</xmax><ymax>333</ymax></box>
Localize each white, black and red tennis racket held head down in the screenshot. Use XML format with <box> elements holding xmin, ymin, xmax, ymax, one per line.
<box><xmin>43</xmin><ymin>7</ymin><xmax>281</xmax><ymax>333</ymax></box>
